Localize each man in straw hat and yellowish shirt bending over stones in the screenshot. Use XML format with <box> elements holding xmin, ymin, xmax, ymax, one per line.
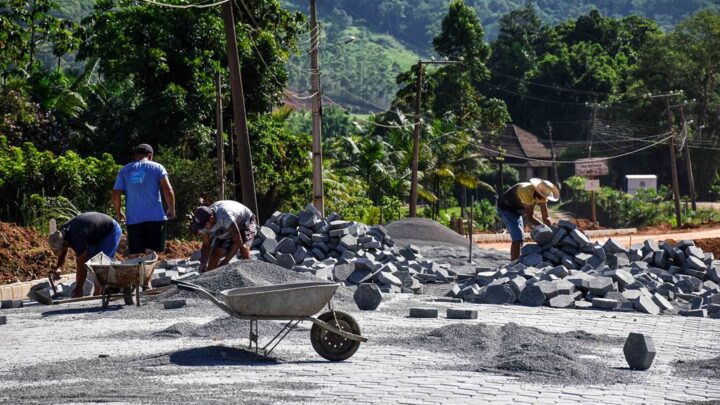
<box><xmin>497</xmin><ymin>178</ymin><xmax>560</xmax><ymax>260</ymax></box>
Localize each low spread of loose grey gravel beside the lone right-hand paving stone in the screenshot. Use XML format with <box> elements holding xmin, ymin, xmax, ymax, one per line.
<box><xmin>387</xmin><ymin>323</ymin><xmax>629</xmax><ymax>384</ymax></box>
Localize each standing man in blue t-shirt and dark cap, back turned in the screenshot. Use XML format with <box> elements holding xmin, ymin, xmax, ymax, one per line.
<box><xmin>112</xmin><ymin>143</ymin><xmax>175</xmax><ymax>258</ymax></box>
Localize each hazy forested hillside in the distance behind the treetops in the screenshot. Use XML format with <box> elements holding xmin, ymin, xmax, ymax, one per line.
<box><xmin>283</xmin><ymin>0</ymin><xmax>720</xmax><ymax>112</ymax></box>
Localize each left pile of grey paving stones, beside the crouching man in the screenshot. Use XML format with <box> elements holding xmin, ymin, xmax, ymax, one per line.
<box><xmin>252</xmin><ymin>205</ymin><xmax>456</xmax><ymax>293</ymax></box>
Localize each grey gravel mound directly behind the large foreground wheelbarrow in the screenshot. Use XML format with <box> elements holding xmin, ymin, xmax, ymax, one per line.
<box><xmin>150</xmin><ymin>260</ymin><xmax>352</xmax><ymax>301</ymax></box>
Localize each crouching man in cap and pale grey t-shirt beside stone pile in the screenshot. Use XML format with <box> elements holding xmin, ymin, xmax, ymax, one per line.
<box><xmin>192</xmin><ymin>200</ymin><xmax>257</xmax><ymax>273</ymax></box>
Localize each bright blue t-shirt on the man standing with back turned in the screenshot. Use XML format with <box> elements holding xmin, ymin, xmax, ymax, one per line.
<box><xmin>113</xmin><ymin>160</ymin><xmax>167</xmax><ymax>225</ymax></box>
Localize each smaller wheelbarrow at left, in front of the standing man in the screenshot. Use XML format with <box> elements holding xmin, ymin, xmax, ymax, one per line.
<box><xmin>85</xmin><ymin>252</ymin><xmax>158</xmax><ymax>308</ymax></box>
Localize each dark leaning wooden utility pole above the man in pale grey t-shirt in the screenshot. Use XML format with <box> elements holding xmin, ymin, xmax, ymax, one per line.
<box><xmin>222</xmin><ymin>1</ymin><xmax>259</xmax><ymax>216</ymax></box>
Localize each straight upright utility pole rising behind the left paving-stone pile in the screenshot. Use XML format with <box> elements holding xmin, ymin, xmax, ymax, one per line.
<box><xmin>310</xmin><ymin>0</ymin><xmax>325</xmax><ymax>215</ymax></box>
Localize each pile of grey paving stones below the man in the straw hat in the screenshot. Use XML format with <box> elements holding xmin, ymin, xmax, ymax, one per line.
<box><xmin>448</xmin><ymin>221</ymin><xmax>720</xmax><ymax>319</ymax></box>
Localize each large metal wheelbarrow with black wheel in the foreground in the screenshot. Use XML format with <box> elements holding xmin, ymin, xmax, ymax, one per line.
<box><xmin>173</xmin><ymin>281</ymin><xmax>367</xmax><ymax>361</ymax></box>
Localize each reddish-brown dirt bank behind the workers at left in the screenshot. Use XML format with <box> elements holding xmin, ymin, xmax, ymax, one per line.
<box><xmin>0</xmin><ymin>222</ymin><xmax>200</xmax><ymax>285</ymax></box>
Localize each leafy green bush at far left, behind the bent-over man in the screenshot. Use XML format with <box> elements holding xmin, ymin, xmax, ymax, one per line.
<box><xmin>0</xmin><ymin>136</ymin><xmax>120</xmax><ymax>226</ymax></box>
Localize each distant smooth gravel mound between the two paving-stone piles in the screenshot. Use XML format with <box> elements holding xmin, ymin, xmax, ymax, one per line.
<box><xmin>385</xmin><ymin>218</ymin><xmax>468</xmax><ymax>246</ymax></box>
